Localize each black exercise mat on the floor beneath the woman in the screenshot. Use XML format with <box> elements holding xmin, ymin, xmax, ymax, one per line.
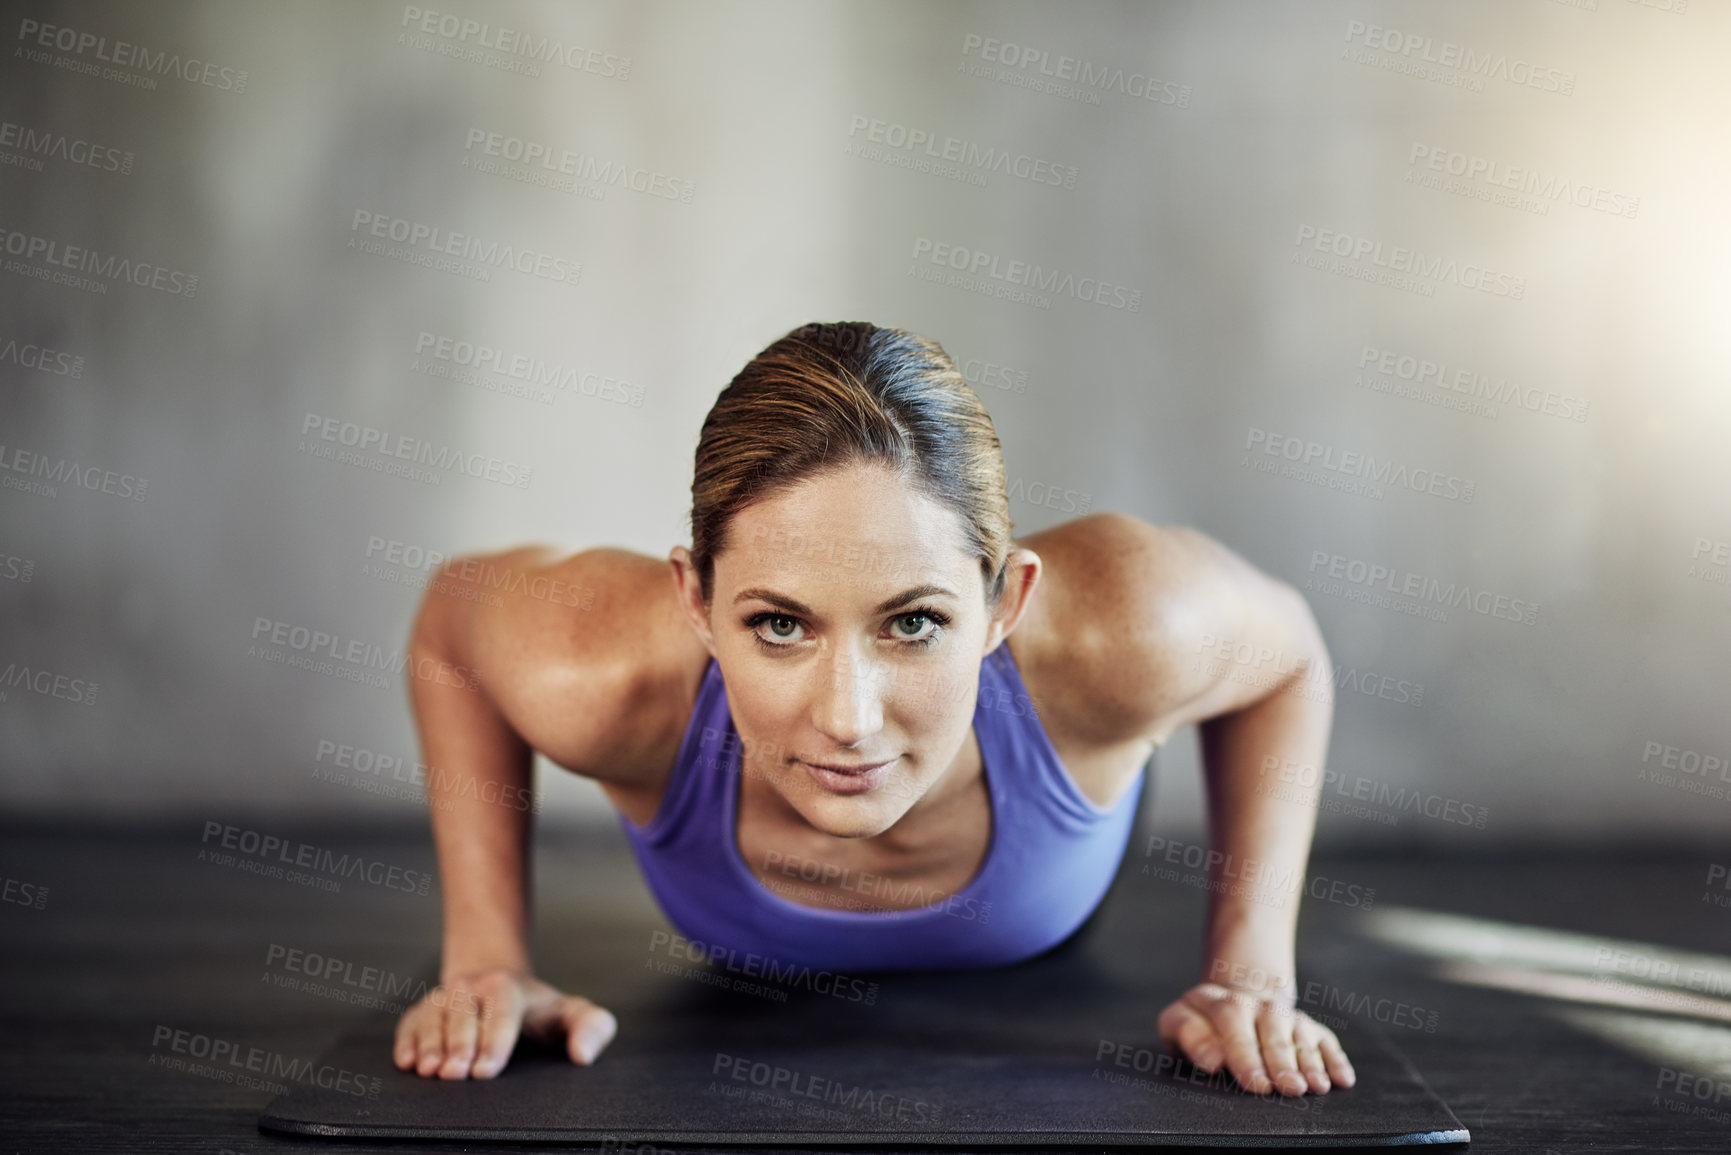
<box><xmin>260</xmin><ymin>843</ymin><xmax>1468</xmax><ymax>1155</ymax></box>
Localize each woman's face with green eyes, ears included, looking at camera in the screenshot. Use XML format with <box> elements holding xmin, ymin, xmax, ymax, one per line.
<box><xmin>672</xmin><ymin>464</ymin><xmax>1039</xmax><ymax>838</ymax></box>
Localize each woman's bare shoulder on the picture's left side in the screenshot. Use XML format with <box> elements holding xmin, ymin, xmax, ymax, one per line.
<box><xmin>445</xmin><ymin>545</ymin><xmax>708</xmax><ymax>783</ymax></box>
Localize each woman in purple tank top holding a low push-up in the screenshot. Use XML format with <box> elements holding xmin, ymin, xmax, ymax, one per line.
<box><xmin>395</xmin><ymin>322</ymin><xmax>1354</xmax><ymax>1094</ymax></box>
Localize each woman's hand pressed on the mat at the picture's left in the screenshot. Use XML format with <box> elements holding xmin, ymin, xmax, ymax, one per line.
<box><xmin>391</xmin><ymin>970</ymin><xmax>618</xmax><ymax>1079</ymax></box>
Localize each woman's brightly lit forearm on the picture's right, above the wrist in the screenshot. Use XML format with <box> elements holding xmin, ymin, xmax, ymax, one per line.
<box><xmin>1201</xmin><ymin>637</ymin><xmax>1335</xmax><ymax>994</ymax></box>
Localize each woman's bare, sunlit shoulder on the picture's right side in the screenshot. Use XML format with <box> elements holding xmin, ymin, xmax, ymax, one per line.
<box><xmin>1013</xmin><ymin>513</ymin><xmax>1302</xmax><ymax>746</ymax></box>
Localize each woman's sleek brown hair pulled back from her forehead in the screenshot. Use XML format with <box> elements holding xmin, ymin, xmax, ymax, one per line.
<box><xmin>691</xmin><ymin>320</ymin><xmax>1011</xmax><ymax>606</ymax></box>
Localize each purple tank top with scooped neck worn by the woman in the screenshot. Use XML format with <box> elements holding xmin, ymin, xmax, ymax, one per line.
<box><xmin>620</xmin><ymin>644</ymin><xmax>1148</xmax><ymax>971</ymax></box>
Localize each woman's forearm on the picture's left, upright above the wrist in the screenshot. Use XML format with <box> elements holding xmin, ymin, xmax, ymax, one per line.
<box><xmin>410</xmin><ymin>592</ymin><xmax>533</xmax><ymax>978</ymax></box>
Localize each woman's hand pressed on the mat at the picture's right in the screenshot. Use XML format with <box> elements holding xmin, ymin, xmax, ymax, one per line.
<box><xmin>1158</xmin><ymin>982</ymin><xmax>1357</xmax><ymax>1094</ymax></box>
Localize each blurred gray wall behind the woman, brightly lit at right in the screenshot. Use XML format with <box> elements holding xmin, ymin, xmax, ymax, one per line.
<box><xmin>0</xmin><ymin>0</ymin><xmax>1731</xmax><ymax>847</ymax></box>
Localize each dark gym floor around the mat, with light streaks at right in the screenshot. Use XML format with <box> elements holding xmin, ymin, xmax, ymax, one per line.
<box><xmin>0</xmin><ymin>821</ymin><xmax>1731</xmax><ymax>1155</ymax></box>
